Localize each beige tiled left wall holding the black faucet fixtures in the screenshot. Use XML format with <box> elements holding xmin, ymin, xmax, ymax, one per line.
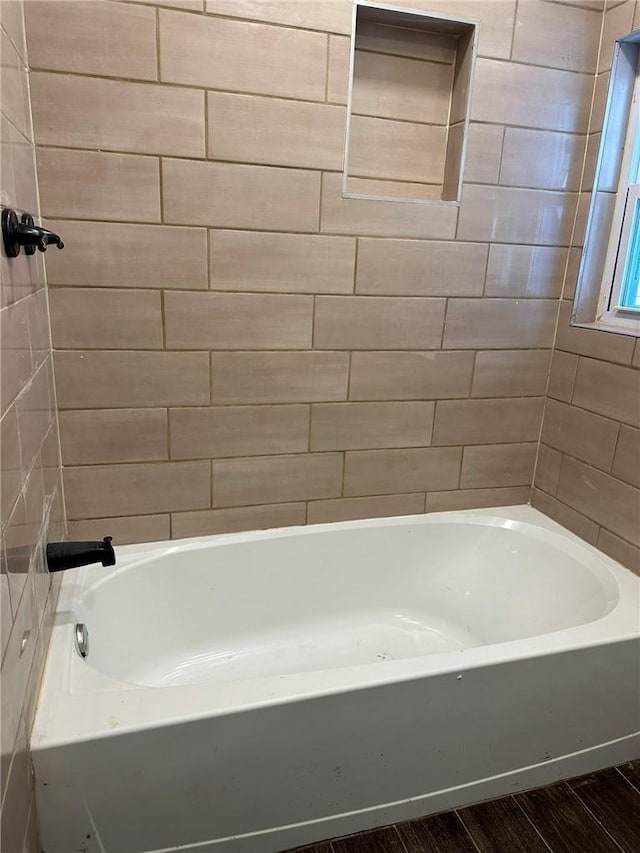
<box><xmin>0</xmin><ymin>0</ymin><xmax>65</xmax><ymax>853</ymax></box>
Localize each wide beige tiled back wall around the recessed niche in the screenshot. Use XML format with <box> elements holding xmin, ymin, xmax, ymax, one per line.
<box><xmin>27</xmin><ymin>0</ymin><xmax>635</xmax><ymax>580</ymax></box>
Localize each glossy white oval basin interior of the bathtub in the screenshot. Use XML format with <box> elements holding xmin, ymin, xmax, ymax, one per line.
<box><xmin>78</xmin><ymin>515</ymin><xmax>618</xmax><ymax>687</ymax></box>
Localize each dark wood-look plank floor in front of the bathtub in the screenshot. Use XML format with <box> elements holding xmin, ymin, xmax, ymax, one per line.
<box><xmin>296</xmin><ymin>760</ymin><xmax>640</xmax><ymax>853</ymax></box>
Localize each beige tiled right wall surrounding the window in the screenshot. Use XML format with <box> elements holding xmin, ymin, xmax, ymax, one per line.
<box><xmin>532</xmin><ymin>0</ymin><xmax>640</xmax><ymax>574</ymax></box>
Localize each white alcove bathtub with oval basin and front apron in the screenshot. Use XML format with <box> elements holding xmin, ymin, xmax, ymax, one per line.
<box><xmin>32</xmin><ymin>507</ymin><xmax>640</xmax><ymax>853</ymax></box>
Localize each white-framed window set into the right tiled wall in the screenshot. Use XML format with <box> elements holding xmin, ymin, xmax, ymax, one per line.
<box><xmin>572</xmin><ymin>32</ymin><xmax>640</xmax><ymax>336</ymax></box>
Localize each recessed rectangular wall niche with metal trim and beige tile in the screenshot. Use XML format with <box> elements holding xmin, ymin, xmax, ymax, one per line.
<box><xmin>342</xmin><ymin>3</ymin><xmax>477</xmax><ymax>204</ymax></box>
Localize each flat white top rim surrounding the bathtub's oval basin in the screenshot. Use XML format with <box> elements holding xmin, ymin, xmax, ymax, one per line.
<box><xmin>32</xmin><ymin>505</ymin><xmax>640</xmax><ymax>749</ymax></box>
